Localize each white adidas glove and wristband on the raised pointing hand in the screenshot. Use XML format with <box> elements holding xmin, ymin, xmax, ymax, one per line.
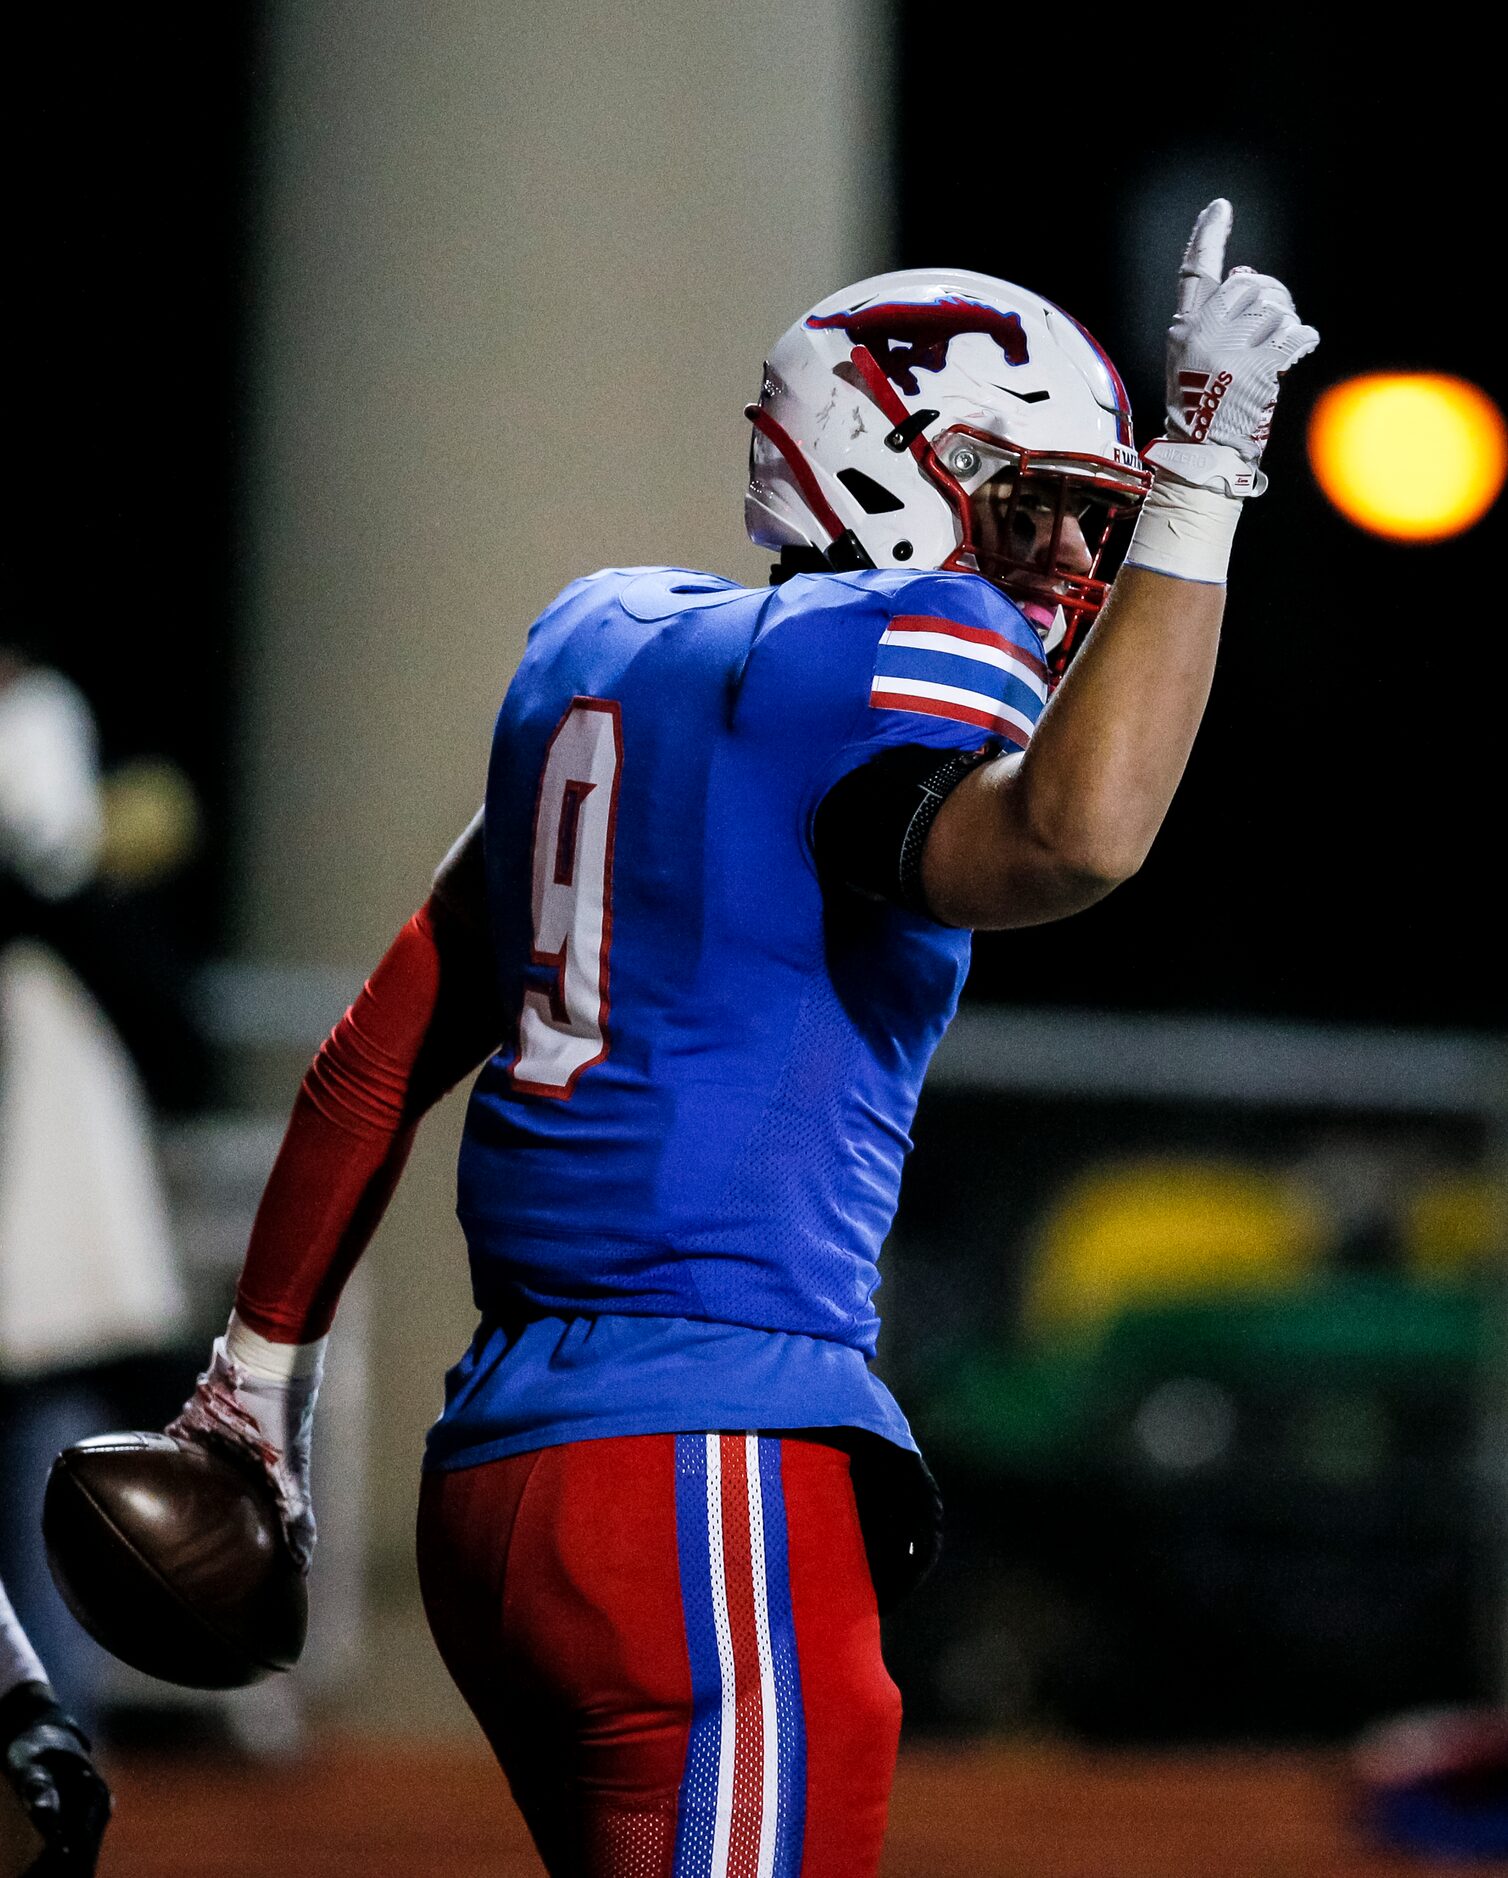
<box><xmin>1127</xmin><ymin>195</ymin><xmax>1320</xmax><ymax>584</ymax></box>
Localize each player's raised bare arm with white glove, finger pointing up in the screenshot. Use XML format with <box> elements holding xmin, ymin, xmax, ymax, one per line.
<box><xmin>922</xmin><ymin>199</ymin><xmax>1318</xmax><ymax>928</ymax></box>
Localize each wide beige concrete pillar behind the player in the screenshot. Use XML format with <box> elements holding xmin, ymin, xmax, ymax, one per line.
<box><xmin>239</xmin><ymin>0</ymin><xmax>890</xmax><ymax>1705</ymax></box>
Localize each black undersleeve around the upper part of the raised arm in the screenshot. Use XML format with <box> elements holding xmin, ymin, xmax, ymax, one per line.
<box><xmin>813</xmin><ymin>744</ymin><xmax>993</xmax><ymax>913</ymax></box>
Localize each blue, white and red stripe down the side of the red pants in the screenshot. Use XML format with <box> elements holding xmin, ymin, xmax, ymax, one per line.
<box><xmin>674</xmin><ymin>1435</ymin><xmax>806</xmax><ymax>1878</ymax></box>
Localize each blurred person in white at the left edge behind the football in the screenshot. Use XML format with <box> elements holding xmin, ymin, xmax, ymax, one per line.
<box><xmin>0</xmin><ymin>652</ymin><xmax>186</xmax><ymax>1713</ymax></box>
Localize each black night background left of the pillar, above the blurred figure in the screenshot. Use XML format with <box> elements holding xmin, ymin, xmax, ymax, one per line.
<box><xmin>9</xmin><ymin>6</ymin><xmax>259</xmax><ymax>950</ymax></box>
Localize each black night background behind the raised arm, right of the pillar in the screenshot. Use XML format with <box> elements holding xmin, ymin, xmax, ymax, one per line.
<box><xmin>898</xmin><ymin>44</ymin><xmax>1508</xmax><ymax>1027</ymax></box>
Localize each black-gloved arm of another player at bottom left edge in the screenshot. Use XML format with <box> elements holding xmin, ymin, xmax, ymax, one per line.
<box><xmin>0</xmin><ymin>1585</ymin><xmax>111</xmax><ymax>1878</ymax></box>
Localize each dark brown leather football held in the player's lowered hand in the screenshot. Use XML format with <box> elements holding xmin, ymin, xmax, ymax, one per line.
<box><xmin>41</xmin><ymin>1435</ymin><xmax>308</xmax><ymax>1688</ymax></box>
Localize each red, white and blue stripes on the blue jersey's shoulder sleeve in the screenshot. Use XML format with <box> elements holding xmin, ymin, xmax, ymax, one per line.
<box><xmin>869</xmin><ymin>614</ymin><xmax>1048</xmax><ymax>749</ymax></box>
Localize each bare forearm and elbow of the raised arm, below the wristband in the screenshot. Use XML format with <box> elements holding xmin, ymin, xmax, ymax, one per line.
<box><xmin>922</xmin><ymin>567</ymin><xmax>1224</xmax><ymax>930</ymax></box>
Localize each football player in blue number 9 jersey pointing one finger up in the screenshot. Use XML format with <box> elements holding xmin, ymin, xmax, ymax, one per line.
<box><xmin>175</xmin><ymin>201</ymin><xmax>1316</xmax><ymax>1878</ymax></box>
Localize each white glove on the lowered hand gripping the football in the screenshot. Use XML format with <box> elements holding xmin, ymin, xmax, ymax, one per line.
<box><xmin>167</xmin><ymin>1313</ymin><xmax>327</xmax><ymax>1572</ymax></box>
